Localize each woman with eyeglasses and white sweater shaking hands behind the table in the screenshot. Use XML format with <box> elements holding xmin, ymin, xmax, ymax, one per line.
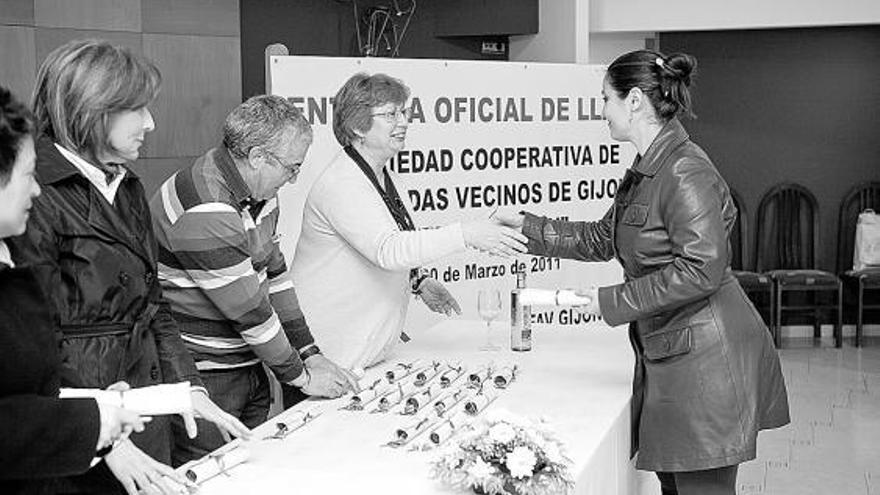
<box><xmin>293</xmin><ymin>73</ymin><xmax>525</xmax><ymax>369</ymax></box>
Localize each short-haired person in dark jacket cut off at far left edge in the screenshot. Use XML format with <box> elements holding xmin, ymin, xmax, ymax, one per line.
<box><xmin>0</xmin><ymin>87</ymin><xmax>143</xmax><ymax>494</ymax></box>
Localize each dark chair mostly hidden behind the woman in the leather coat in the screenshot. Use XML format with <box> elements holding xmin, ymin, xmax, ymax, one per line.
<box><xmin>730</xmin><ymin>189</ymin><xmax>774</xmax><ymax>332</ymax></box>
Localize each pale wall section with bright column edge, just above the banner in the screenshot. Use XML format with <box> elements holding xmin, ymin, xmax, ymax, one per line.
<box><xmin>510</xmin><ymin>0</ymin><xmax>590</xmax><ymax>64</ymax></box>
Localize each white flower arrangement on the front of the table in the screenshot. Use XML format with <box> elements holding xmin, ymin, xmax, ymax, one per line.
<box><xmin>433</xmin><ymin>410</ymin><xmax>574</xmax><ymax>495</ymax></box>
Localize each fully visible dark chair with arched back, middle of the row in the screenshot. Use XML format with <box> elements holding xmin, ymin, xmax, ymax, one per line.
<box><xmin>755</xmin><ymin>183</ymin><xmax>843</xmax><ymax>347</ymax></box>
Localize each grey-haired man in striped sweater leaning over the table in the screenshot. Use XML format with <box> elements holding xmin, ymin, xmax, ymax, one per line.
<box><xmin>150</xmin><ymin>96</ymin><xmax>357</xmax><ymax>463</ymax></box>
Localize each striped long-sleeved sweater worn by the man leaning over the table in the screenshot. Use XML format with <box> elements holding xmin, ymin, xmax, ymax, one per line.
<box><xmin>150</xmin><ymin>146</ymin><xmax>314</xmax><ymax>382</ymax></box>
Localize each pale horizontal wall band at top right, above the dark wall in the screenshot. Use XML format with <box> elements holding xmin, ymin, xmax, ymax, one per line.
<box><xmin>588</xmin><ymin>0</ymin><xmax>880</xmax><ymax>33</ymax></box>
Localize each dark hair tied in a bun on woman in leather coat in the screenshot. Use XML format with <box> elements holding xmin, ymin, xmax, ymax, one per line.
<box><xmin>606</xmin><ymin>50</ymin><xmax>697</xmax><ymax>122</ymax></box>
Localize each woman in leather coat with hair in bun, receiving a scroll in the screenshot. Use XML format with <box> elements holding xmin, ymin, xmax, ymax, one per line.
<box><xmin>496</xmin><ymin>50</ymin><xmax>789</xmax><ymax>495</ymax></box>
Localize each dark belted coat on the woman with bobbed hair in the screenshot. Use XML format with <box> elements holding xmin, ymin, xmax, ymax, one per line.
<box><xmin>9</xmin><ymin>137</ymin><xmax>201</xmax><ymax>491</ymax></box>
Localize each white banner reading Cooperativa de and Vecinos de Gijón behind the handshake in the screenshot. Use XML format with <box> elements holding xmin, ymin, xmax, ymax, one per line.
<box><xmin>270</xmin><ymin>56</ymin><xmax>635</xmax><ymax>333</ymax></box>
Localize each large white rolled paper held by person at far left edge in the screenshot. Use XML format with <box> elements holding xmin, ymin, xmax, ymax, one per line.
<box><xmin>59</xmin><ymin>382</ymin><xmax>192</xmax><ymax>416</ymax></box>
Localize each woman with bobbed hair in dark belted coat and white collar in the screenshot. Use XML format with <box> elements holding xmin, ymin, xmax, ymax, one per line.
<box><xmin>11</xmin><ymin>40</ymin><xmax>249</xmax><ymax>495</ymax></box>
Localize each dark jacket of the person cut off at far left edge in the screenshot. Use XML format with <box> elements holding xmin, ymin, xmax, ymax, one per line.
<box><xmin>0</xmin><ymin>264</ymin><xmax>101</xmax><ymax>494</ymax></box>
